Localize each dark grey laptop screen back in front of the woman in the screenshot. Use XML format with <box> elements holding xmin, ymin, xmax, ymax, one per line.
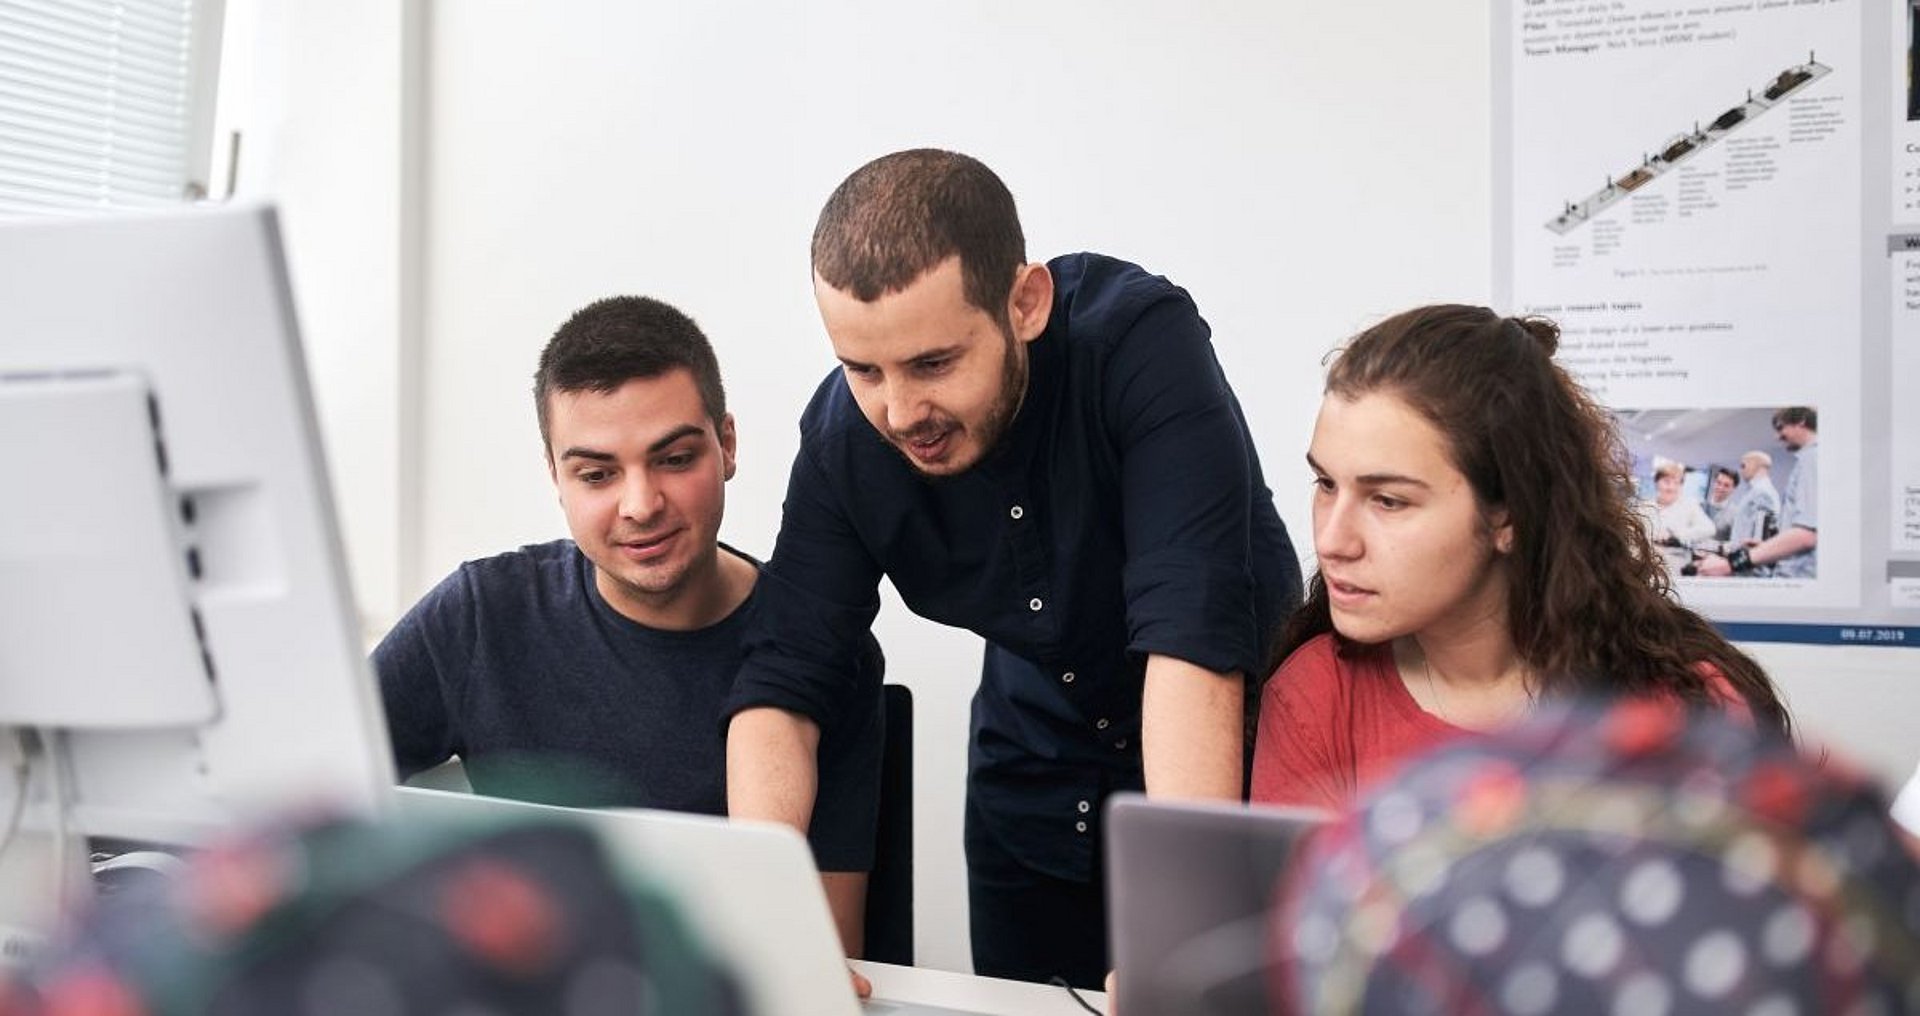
<box><xmin>1106</xmin><ymin>793</ymin><xmax>1331</xmax><ymax>1016</ymax></box>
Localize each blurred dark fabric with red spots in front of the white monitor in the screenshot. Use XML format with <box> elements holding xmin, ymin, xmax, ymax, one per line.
<box><xmin>11</xmin><ymin>820</ymin><xmax>745</xmax><ymax>1016</ymax></box>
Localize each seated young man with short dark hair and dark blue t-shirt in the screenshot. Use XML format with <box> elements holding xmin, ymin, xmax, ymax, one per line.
<box><xmin>372</xmin><ymin>298</ymin><xmax>881</xmax><ymax>953</ymax></box>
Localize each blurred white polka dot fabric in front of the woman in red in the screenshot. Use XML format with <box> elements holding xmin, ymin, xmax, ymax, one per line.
<box><xmin>1271</xmin><ymin>701</ymin><xmax>1920</xmax><ymax>1016</ymax></box>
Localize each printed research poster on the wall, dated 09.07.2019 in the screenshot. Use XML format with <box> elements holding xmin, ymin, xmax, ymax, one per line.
<box><xmin>1494</xmin><ymin>0</ymin><xmax>1920</xmax><ymax>647</ymax></box>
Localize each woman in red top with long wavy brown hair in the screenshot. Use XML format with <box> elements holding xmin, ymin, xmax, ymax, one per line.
<box><xmin>1252</xmin><ymin>305</ymin><xmax>1789</xmax><ymax>807</ymax></box>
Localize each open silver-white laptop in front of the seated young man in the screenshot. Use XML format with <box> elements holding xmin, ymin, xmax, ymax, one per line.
<box><xmin>396</xmin><ymin>787</ymin><xmax>1085</xmax><ymax>1016</ymax></box>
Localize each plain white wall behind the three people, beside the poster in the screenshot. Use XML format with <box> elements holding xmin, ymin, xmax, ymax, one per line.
<box><xmin>266</xmin><ymin>0</ymin><xmax>1916</xmax><ymax>970</ymax></box>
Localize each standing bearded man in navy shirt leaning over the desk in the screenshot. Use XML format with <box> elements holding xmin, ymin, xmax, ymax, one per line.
<box><xmin>728</xmin><ymin>150</ymin><xmax>1300</xmax><ymax>987</ymax></box>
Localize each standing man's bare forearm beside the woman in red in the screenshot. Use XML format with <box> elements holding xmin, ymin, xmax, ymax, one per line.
<box><xmin>1140</xmin><ymin>655</ymin><xmax>1246</xmax><ymax>801</ymax></box>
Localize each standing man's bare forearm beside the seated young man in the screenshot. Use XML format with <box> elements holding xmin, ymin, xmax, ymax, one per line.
<box><xmin>726</xmin><ymin>709</ymin><xmax>820</xmax><ymax>834</ymax></box>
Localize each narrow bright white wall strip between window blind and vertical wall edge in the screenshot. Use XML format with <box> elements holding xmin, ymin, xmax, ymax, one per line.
<box><xmin>234</xmin><ymin>0</ymin><xmax>413</xmax><ymax>630</ymax></box>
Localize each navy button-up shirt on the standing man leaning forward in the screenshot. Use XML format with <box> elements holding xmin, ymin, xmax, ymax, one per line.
<box><xmin>730</xmin><ymin>254</ymin><xmax>1300</xmax><ymax>880</ymax></box>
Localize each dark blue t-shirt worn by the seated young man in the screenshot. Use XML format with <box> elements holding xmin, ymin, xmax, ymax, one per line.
<box><xmin>372</xmin><ymin>540</ymin><xmax>883</xmax><ymax>872</ymax></box>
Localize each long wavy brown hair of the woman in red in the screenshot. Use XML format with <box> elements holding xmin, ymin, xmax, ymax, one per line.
<box><xmin>1269</xmin><ymin>305</ymin><xmax>1789</xmax><ymax>730</ymax></box>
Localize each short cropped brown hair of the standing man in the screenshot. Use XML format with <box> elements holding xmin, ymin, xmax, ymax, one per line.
<box><xmin>812</xmin><ymin>148</ymin><xmax>1027</xmax><ymax>323</ymax></box>
